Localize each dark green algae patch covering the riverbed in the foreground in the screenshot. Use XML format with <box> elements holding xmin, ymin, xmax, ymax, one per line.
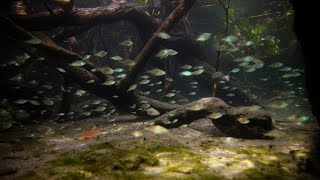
<box><xmin>44</xmin><ymin>139</ymin><xmax>193</xmax><ymax>177</ymax></box>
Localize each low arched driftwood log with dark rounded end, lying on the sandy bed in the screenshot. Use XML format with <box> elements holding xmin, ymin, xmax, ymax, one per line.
<box><xmin>154</xmin><ymin>97</ymin><xmax>273</xmax><ymax>138</ymax></box>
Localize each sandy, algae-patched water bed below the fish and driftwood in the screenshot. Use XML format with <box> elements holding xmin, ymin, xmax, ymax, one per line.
<box><xmin>1</xmin><ymin>110</ymin><xmax>314</xmax><ymax>179</ymax></box>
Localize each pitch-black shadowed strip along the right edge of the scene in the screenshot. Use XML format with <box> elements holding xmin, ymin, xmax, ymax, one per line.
<box><xmin>291</xmin><ymin>0</ymin><xmax>320</xmax><ymax>175</ymax></box>
